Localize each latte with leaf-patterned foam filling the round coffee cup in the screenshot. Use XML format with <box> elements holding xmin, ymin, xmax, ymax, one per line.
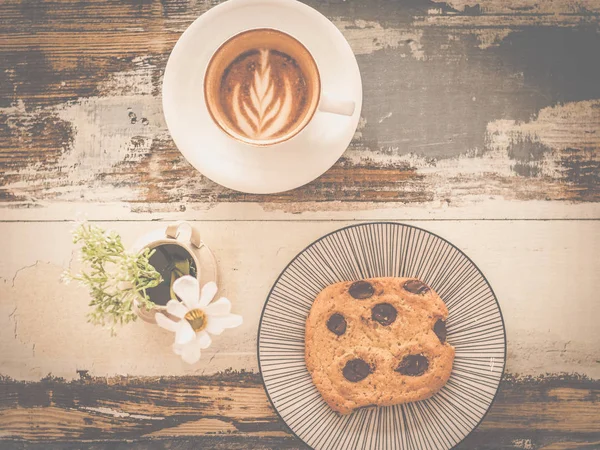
<box><xmin>205</xmin><ymin>29</ymin><xmax>320</xmax><ymax>145</ymax></box>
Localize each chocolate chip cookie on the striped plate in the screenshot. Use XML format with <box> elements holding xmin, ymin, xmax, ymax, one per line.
<box><xmin>305</xmin><ymin>278</ymin><xmax>454</xmax><ymax>414</ymax></box>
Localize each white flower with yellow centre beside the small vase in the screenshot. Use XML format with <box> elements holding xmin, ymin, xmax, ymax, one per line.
<box><xmin>155</xmin><ymin>275</ymin><xmax>242</xmax><ymax>364</ymax></box>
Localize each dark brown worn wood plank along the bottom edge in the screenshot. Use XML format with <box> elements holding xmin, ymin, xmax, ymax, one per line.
<box><xmin>0</xmin><ymin>372</ymin><xmax>600</xmax><ymax>449</ymax></box>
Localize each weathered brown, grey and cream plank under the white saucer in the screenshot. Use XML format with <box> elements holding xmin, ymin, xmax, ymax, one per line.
<box><xmin>0</xmin><ymin>0</ymin><xmax>600</xmax><ymax>207</ymax></box>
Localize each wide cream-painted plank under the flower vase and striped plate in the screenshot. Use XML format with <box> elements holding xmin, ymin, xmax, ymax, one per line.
<box><xmin>0</xmin><ymin>220</ymin><xmax>600</xmax><ymax>381</ymax></box>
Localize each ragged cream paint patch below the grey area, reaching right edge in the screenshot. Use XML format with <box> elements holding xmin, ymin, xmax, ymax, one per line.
<box><xmin>338</xmin><ymin>101</ymin><xmax>600</xmax><ymax>204</ymax></box>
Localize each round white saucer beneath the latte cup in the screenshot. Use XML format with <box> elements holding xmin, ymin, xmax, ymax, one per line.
<box><xmin>163</xmin><ymin>0</ymin><xmax>362</xmax><ymax>194</ymax></box>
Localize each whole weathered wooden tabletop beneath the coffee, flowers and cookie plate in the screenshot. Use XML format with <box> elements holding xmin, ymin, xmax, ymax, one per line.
<box><xmin>0</xmin><ymin>0</ymin><xmax>600</xmax><ymax>450</ymax></box>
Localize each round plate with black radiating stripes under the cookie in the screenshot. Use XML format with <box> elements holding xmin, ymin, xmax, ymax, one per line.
<box><xmin>258</xmin><ymin>223</ymin><xmax>506</xmax><ymax>450</ymax></box>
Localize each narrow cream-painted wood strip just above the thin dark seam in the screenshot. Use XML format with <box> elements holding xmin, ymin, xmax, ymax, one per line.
<box><xmin>0</xmin><ymin>199</ymin><xmax>600</xmax><ymax>223</ymax></box>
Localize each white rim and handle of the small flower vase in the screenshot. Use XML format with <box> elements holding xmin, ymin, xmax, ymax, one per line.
<box><xmin>132</xmin><ymin>221</ymin><xmax>218</xmax><ymax>323</ymax></box>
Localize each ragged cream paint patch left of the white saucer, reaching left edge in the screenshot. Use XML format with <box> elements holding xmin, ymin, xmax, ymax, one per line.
<box><xmin>0</xmin><ymin>89</ymin><xmax>168</xmax><ymax>200</ymax></box>
